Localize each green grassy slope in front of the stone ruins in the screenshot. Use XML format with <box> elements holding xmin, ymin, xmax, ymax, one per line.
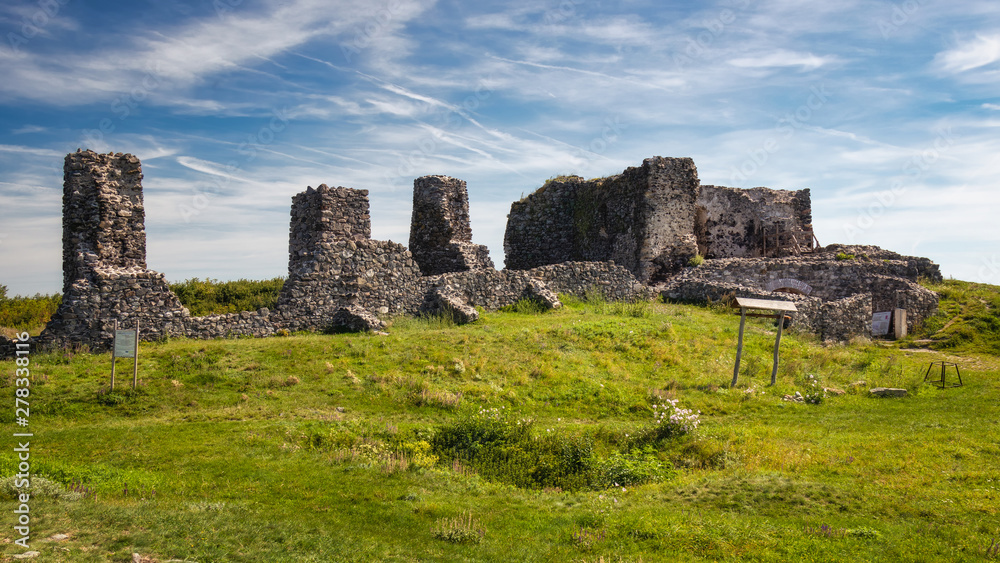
<box><xmin>0</xmin><ymin>282</ymin><xmax>1000</xmax><ymax>563</ymax></box>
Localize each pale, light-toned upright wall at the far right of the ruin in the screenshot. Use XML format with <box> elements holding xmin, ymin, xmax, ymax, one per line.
<box><xmin>695</xmin><ymin>185</ymin><xmax>813</xmax><ymax>258</ymax></box>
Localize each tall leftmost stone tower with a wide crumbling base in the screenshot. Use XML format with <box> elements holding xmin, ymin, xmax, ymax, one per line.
<box><xmin>40</xmin><ymin>150</ymin><xmax>188</xmax><ymax>348</ymax></box>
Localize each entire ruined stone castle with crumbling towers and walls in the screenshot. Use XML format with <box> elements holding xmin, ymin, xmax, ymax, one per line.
<box><xmin>0</xmin><ymin>151</ymin><xmax>941</xmax><ymax>350</ymax></box>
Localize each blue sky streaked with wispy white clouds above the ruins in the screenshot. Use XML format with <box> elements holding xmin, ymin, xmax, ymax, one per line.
<box><xmin>0</xmin><ymin>0</ymin><xmax>1000</xmax><ymax>295</ymax></box>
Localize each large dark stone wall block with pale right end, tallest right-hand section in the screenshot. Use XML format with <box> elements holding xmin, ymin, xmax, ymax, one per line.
<box><xmin>504</xmin><ymin>157</ymin><xmax>699</xmax><ymax>283</ymax></box>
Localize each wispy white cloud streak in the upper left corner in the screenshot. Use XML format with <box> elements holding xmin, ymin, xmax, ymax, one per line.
<box><xmin>0</xmin><ymin>0</ymin><xmax>436</xmax><ymax>110</ymax></box>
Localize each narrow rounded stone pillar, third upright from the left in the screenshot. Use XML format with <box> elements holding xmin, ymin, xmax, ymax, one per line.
<box><xmin>410</xmin><ymin>176</ymin><xmax>494</xmax><ymax>276</ymax></box>
